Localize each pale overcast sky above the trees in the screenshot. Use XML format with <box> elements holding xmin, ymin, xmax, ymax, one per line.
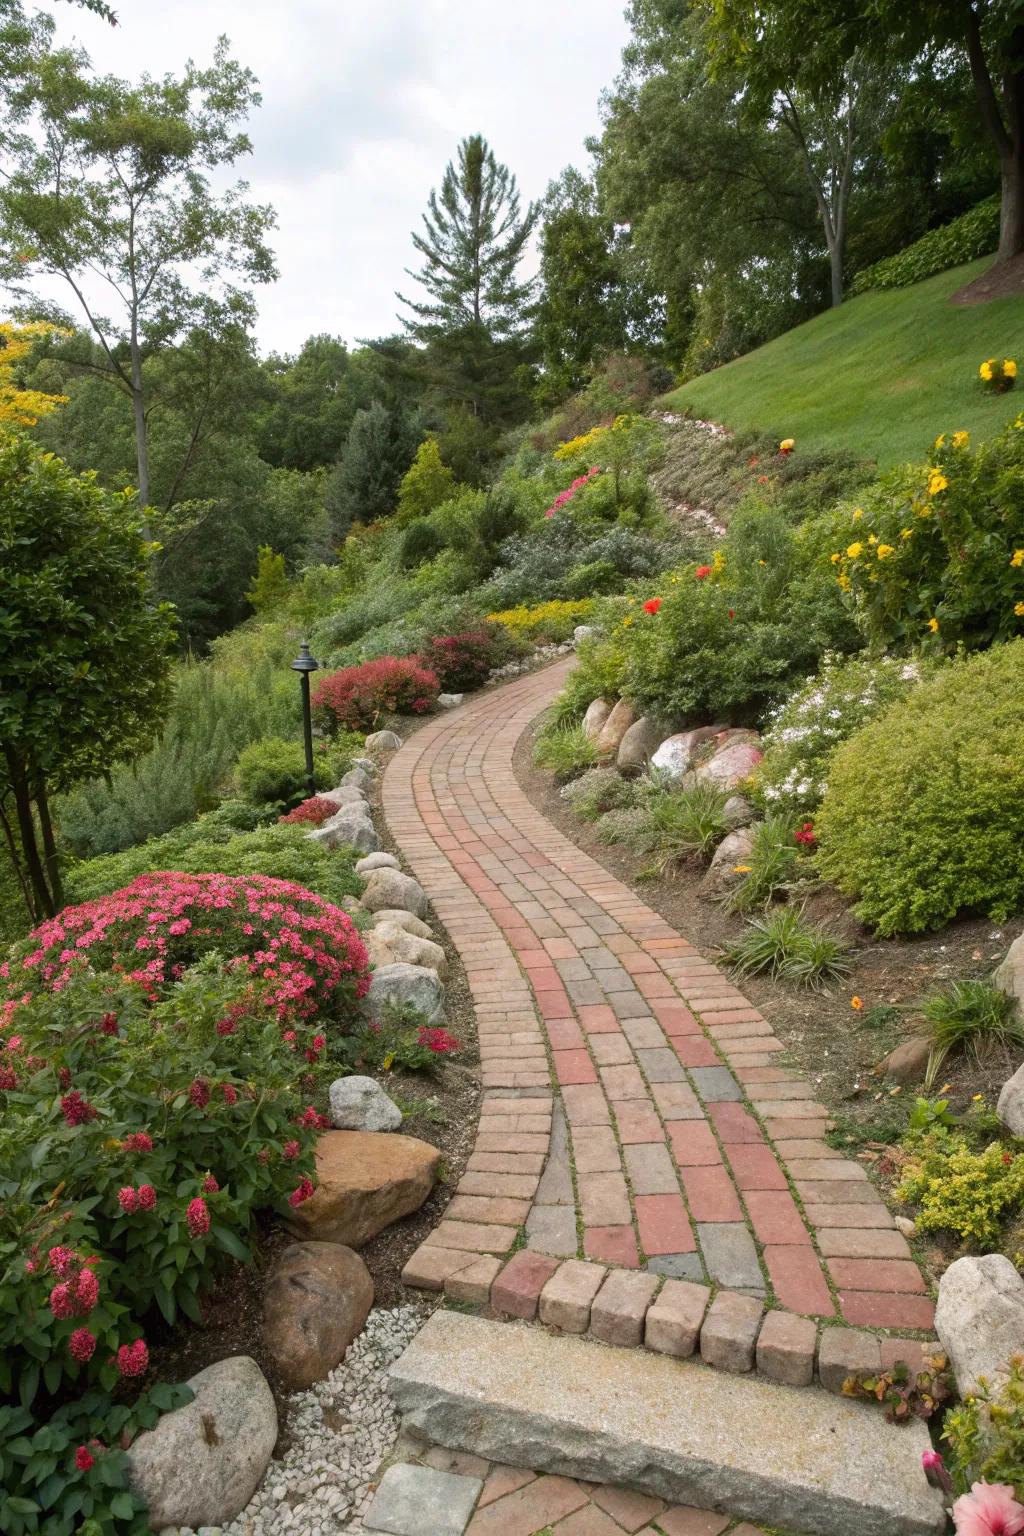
<box><xmin>52</xmin><ymin>0</ymin><xmax>626</xmax><ymax>352</ymax></box>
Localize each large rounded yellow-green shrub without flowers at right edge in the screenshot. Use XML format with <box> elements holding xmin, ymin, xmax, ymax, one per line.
<box><xmin>815</xmin><ymin>641</ymin><xmax>1024</xmax><ymax>935</ymax></box>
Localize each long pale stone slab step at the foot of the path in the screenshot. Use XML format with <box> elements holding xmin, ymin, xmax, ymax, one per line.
<box><xmin>390</xmin><ymin>1310</ymin><xmax>946</xmax><ymax>1536</ymax></box>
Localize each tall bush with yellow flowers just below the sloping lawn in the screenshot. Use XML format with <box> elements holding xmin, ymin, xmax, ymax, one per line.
<box><xmin>831</xmin><ymin>425</ymin><xmax>1024</xmax><ymax>653</ymax></box>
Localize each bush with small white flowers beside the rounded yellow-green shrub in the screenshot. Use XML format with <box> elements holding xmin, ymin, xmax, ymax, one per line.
<box><xmin>757</xmin><ymin>656</ymin><xmax>924</xmax><ymax>814</ymax></box>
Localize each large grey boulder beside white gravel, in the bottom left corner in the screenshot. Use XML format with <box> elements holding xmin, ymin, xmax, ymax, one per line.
<box><xmin>127</xmin><ymin>1355</ymin><xmax>278</xmax><ymax>1531</ymax></box>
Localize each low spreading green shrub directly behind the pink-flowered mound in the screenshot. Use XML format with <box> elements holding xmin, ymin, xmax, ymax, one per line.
<box><xmin>68</xmin><ymin>802</ymin><xmax>362</xmax><ymax>906</ymax></box>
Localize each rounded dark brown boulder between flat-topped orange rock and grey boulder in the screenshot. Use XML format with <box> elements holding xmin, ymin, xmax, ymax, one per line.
<box><xmin>263</xmin><ymin>1243</ymin><xmax>373</xmax><ymax>1392</ymax></box>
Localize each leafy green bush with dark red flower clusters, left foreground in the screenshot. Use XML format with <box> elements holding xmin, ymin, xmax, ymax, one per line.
<box><xmin>0</xmin><ymin>954</ymin><xmax>324</xmax><ymax>1531</ymax></box>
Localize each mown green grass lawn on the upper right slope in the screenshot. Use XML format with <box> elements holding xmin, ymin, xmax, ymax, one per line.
<box><xmin>663</xmin><ymin>257</ymin><xmax>1024</xmax><ymax>467</ymax></box>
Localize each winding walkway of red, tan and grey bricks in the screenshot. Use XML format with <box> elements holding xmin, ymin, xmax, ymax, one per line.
<box><xmin>384</xmin><ymin>660</ymin><xmax>933</xmax><ymax>1330</ymax></box>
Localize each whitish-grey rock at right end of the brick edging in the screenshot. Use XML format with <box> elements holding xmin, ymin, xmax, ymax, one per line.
<box><xmin>935</xmin><ymin>1253</ymin><xmax>1024</xmax><ymax>1396</ymax></box>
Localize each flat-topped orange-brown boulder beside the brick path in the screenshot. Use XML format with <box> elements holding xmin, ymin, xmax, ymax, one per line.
<box><xmin>289</xmin><ymin>1130</ymin><xmax>441</xmax><ymax>1247</ymax></box>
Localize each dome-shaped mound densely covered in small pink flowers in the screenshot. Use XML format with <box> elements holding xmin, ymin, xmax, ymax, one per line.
<box><xmin>0</xmin><ymin>872</ymin><xmax>370</xmax><ymax>1028</ymax></box>
